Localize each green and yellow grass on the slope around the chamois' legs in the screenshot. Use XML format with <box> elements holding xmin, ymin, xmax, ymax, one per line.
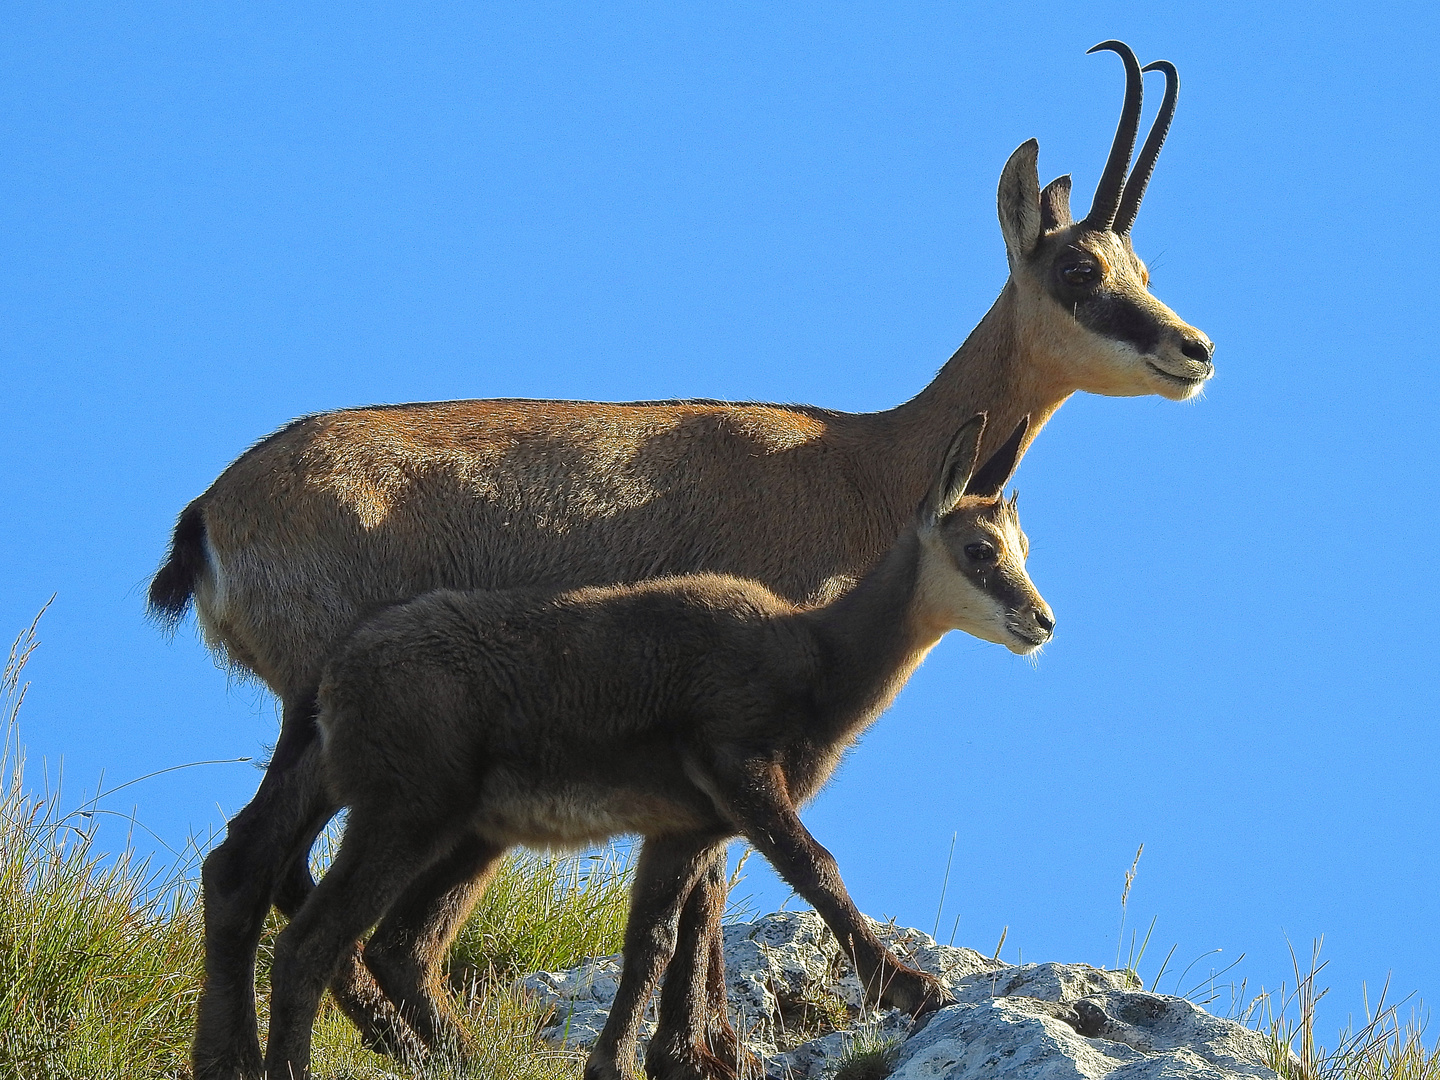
<box><xmin>0</xmin><ymin>616</ymin><xmax>1440</xmax><ymax>1080</ymax></box>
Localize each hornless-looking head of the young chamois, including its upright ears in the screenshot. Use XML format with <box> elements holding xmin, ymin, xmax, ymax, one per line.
<box><xmin>917</xmin><ymin>413</ymin><xmax>1056</xmax><ymax>654</ymax></box>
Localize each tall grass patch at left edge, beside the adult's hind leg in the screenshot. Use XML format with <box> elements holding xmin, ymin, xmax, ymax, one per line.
<box><xmin>0</xmin><ymin>612</ymin><xmax>202</xmax><ymax>1080</ymax></box>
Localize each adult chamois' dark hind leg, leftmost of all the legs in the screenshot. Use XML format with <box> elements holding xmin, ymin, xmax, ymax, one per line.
<box><xmin>192</xmin><ymin>700</ymin><xmax>333</xmax><ymax>1080</ymax></box>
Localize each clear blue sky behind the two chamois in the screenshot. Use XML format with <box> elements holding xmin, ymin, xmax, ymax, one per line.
<box><xmin>0</xmin><ymin>3</ymin><xmax>1440</xmax><ymax>1038</ymax></box>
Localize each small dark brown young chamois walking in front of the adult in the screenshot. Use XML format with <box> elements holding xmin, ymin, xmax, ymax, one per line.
<box><xmin>266</xmin><ymin>415</ymin><xmax>1054</xmax><ymax>1080</ymax></box>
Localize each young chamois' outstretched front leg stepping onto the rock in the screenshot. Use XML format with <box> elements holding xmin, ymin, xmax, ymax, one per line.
<box><xmin>713</xmin><ymin>760</ymin><xmax>955</xmax><ymax>1017</ymax></box>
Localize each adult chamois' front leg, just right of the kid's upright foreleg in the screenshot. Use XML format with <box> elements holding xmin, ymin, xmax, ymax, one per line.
<box><xmin>645</xmin><ymin>848</ymin><xmax>765</xmax><ymax>1080</ymax></box>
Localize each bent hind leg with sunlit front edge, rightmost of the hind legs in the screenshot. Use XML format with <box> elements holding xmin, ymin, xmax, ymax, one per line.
<box><xmin>364</xmin><ymin>835</ymin><xmax>505</xmax><ymax>1057</ymax></box>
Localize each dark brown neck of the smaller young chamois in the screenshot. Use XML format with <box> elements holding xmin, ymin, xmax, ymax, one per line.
<box><xmin>801</xmin><ymin>527</ymin><xmax>945</xmax><ymax>737</ymax></box>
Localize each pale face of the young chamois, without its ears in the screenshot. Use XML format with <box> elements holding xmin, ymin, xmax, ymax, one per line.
<box><xmin>919</xmin><ymin>497</ymin><xmax>1056</xmax><ymax>655</ymax></box>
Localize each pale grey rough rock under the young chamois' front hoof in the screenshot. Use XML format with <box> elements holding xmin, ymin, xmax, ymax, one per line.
<box><xmin>523</xmin><ymin>912</ymin><xmax>1274</xmax><ymax>1080</ymax></box>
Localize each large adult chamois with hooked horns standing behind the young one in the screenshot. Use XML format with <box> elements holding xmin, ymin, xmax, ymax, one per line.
<box><xmin>150</xmin><ymin>42</ymin><xmax>1214</xmax><ymax>1080</ymax></box>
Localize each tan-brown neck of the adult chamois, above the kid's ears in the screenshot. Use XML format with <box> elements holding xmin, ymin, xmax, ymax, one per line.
<box><xmin>852</xmin><ymin>281</ymin><xmax>1077</xmax><ymax>521</ymax></box>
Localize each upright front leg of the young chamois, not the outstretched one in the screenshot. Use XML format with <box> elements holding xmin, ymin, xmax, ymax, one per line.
<box><xmin>585</xmin><ymin>834</ymin><xmax>724</xmax><ymax>1080</ymax></box>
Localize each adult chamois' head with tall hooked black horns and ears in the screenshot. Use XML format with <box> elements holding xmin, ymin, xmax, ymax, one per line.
<box><xmin>998</xmin><ymin>42</ymin><xmax>1215</xmax><ymax>400</ymax></box>
